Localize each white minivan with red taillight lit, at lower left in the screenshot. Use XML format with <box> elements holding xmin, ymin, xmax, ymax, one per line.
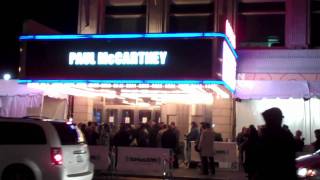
<box><xmin>0</xmin><ymin>117</ymin><xmax>94</xmax><ymax>180</ymax></box>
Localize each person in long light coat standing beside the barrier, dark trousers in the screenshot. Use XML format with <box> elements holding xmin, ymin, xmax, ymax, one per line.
<box><xmin>199</xmin><ymin>123</ymin><xmax>216</xmax><ymax>175</ymax></box>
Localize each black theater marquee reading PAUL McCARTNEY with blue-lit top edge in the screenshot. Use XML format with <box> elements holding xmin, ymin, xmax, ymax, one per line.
<box><xmin>20</xmin><ymin>33</ymin><xmax>237</xmax><ymax>90</ymax></box>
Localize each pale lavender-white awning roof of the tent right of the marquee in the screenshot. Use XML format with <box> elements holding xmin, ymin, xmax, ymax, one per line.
<box><xmin>235</xmin><ymin>80</ymin><xmax>310</xmax><ymax>99</ymax></box>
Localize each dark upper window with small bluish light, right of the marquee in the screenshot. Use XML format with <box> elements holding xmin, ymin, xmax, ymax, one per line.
<box><xmin>237</xmin><ymin>1</ymin><xmax>285</xmax><ymax>48</ymax></box>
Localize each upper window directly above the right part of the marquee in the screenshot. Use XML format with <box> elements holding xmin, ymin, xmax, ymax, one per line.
<box><xmin>168</xmin><ymin>0</ymin><xmax>214</xmax><ymax>32</ymax></box>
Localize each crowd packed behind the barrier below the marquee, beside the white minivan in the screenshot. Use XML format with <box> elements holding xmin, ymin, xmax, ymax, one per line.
<box><xmin>78</xmin><ymin>121</ymin><xmax>181</xmax><ymax>168</ymax></box>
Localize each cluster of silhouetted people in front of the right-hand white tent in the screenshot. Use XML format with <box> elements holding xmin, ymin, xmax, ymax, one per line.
<box><xmin>236</xmin><ymin>108</ymin><xmax>320</xmax><ymax>180</ymax></box>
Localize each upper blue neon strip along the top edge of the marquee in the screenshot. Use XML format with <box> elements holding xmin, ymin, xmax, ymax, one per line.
<box><xmin>19</xmin><ymin>32</ymin><xmax>238</xmax><ymax>59</ymax></box>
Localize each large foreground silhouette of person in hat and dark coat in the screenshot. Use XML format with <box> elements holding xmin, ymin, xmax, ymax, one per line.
<box><xmin>257</xmin><ymin>108</ymin><xmax>297</xmax><ymax>180</ymax></box>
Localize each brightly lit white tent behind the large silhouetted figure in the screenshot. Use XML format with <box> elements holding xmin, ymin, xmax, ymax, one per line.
<box><xmin>235</xmin><ymin>80</ymin><xmax>320</xmax><ymax>144</ymax></box>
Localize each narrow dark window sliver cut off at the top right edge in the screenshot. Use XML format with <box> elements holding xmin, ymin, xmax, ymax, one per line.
<box><xmin>310</xmin><ymin>0</ymin><xmax>320</xmax><ymax>47</ymax></box>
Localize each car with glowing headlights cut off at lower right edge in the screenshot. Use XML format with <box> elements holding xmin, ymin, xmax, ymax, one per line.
<box><xmin>296</xmin><ymin>150</ymin><xmax>320</xmax><ymax>179</ymax></box>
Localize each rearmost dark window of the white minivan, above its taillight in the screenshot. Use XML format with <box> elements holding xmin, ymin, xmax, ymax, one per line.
<box><xmin>51</xmin><ymin>122</ymin><xmax>84</xmax><ymax>145</ymax></box>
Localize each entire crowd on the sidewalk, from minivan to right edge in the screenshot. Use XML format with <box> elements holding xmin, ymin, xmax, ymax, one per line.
<box><xmin>78</xmin><ymin>108</ymin><xmax>320</xmax><ymax>180</ymax></box>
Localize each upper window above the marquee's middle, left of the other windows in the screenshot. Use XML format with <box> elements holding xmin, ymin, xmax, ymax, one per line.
<box><xmin>104</xmin><ymin>0</ymin><xmax>146</xmax><ymax>33</ymax></box>
